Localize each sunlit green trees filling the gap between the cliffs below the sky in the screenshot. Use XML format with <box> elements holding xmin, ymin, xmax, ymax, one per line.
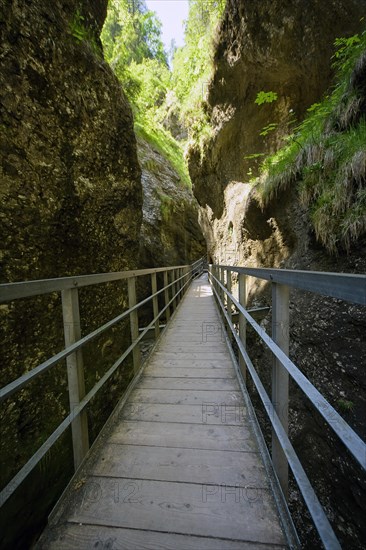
<box><xmin>102</xmin><ymin>0</ymin><xmax>225</xmax><ymax>185</ymax></box>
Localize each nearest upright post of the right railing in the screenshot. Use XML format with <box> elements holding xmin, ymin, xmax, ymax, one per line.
<box><xmin>272</xmin><ymin>283</ymin><xmax>289</xmax><ymax>499</ymax></box>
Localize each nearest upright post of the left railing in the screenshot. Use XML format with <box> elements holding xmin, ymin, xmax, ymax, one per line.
<box><xmin>61</xmin><ymin>288</ymin><xmax>89</xmax><ymax>470</ymax></box>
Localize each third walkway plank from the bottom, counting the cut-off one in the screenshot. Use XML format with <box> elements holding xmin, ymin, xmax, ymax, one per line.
<box><xmin>92</xmin><ymin>443</ymin><xmax>268</xmax><ymax>488</ymax></box>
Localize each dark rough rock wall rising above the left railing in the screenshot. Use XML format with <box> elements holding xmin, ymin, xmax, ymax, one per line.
<box><xmin>0</xmin><ymin>1</ymin><xmax>142</xmax><ymax>281</ymax></box>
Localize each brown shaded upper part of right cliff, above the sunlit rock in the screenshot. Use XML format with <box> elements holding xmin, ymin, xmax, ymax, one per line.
<box><xmin>189</xmin><ymin>0</ymin><xmax>366</xmax><ymax>223</ymax></box>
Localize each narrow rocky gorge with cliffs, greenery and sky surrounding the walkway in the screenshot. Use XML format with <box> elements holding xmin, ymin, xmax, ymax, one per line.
<box><xmin>0</xmin><ymin>0</ymin><xmax>366</xmax><ymax>550</ymax></box>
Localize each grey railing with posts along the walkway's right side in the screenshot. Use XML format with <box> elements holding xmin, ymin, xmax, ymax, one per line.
<box><xmin>208</xmin><ymin>265</ymin><xmax>366</xmax><ymax>549</ymax></box>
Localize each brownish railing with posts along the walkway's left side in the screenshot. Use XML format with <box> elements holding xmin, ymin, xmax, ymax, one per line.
<box><xmin>0</xmin><ymin>259</ymin><xmax>203</xmax><ymax>506</ymax></box>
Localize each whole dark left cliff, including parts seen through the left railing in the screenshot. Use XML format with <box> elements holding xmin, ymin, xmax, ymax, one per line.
<box><xmin>0</xmin><ymin>0</ymin><xmax>193</xmax><ymax>548</ymax></box>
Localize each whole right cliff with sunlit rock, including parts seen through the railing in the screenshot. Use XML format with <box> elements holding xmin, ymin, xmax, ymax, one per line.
<box><xmin>189</xmin><ymin>0</ymin><xmax>366</xmax><ymax>548</ymax></box>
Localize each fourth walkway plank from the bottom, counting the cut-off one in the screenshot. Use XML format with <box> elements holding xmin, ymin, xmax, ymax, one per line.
<box><xmin>110</xmin><ymin>420</ymin><xmax>257</xmax><ymax>452</ymax></box>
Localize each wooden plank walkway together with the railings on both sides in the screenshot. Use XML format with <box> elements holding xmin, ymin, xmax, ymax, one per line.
<box><xmin>0</xmin><ymin>259</ymin><xmax>366</xmax><ymax>550</ymax></box>
